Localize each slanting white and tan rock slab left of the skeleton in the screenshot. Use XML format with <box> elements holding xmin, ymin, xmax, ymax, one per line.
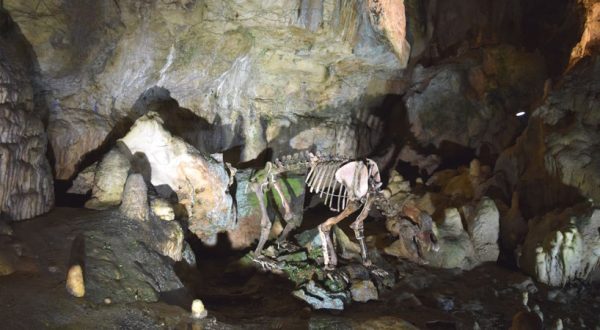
<box><xmin>118</xmin><ymin>112</ymin><xmax>235</xmax><ymax>244</ymax></box>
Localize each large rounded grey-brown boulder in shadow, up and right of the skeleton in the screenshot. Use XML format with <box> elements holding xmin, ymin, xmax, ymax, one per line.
<box><xmin>404</xmin><ymin>46</ymin><xmax>545</xmax><ymax>152</ymax></box>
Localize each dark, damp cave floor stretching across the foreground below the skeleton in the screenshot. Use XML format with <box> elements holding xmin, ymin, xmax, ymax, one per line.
<box><xmin>0</xmin><ymin>208</ymin><xmax>600</xmax><ymax>329</ymax></box>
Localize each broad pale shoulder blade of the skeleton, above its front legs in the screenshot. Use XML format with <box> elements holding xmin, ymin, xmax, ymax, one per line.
<box><xmin>335</xmin><ymin>159</ymin><xmax>382</xmax><ymax>198</ymax></box>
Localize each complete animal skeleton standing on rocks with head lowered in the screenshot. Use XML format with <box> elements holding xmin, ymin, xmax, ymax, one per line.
<box><xmin>249</xmin><ymin>153</ymin><xmax>434</xmax><ymax>270</ymax></box>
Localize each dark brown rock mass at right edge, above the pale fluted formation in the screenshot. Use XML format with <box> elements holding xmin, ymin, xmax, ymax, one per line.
<box><xmin>494</xmin><ymin>56</ymin><xmax>600</xmax><ymax>218</ymax></box>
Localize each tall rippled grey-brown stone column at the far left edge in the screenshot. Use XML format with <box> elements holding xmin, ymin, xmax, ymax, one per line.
<box><xmin>0</xmin><ymin>12</ymin><xmax>54</xmax><ymax>220</ymax></box>
